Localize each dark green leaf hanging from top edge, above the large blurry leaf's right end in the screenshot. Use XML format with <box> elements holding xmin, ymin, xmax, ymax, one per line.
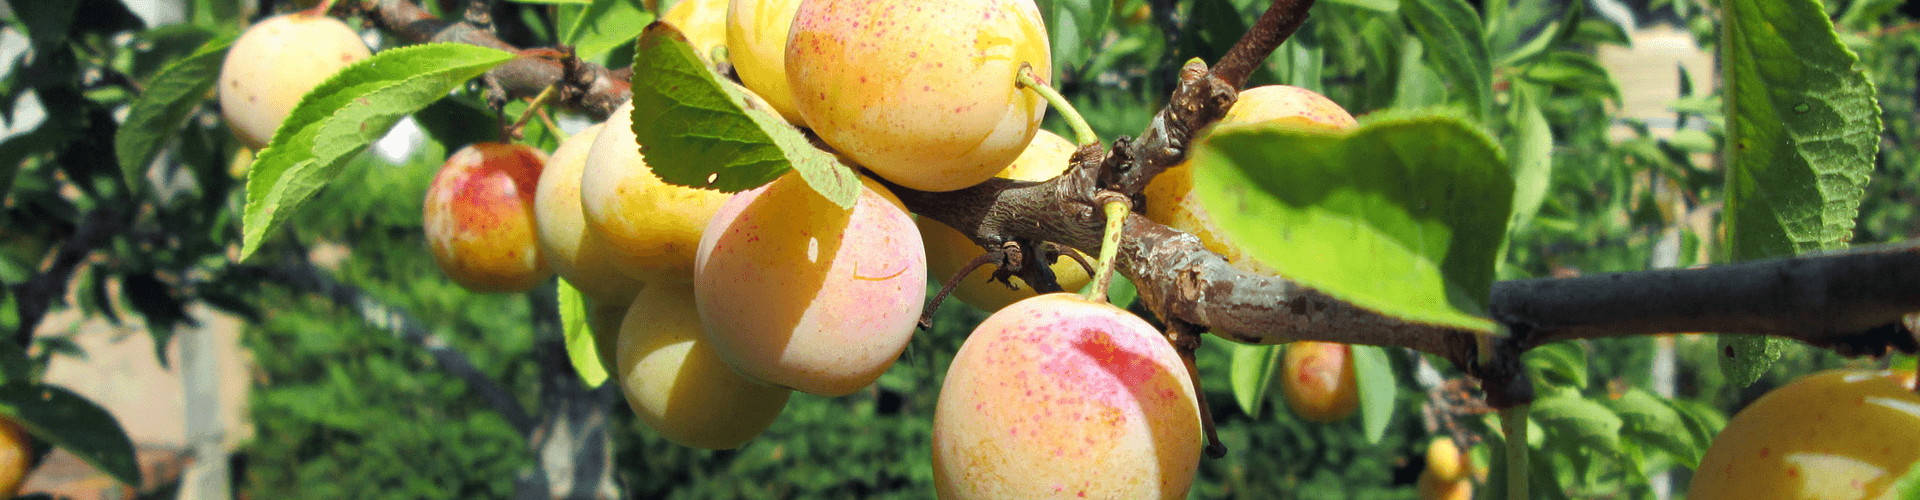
<box><xmin>1400</xmin><ymin>0</ymin><xmax>1494</xmax><ymax>119</ymax></box>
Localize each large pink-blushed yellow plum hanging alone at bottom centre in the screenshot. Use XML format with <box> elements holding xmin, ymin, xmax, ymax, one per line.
<box><xmin>933</xmin><ymin>292</ymin><xmax>1202</xmax><ymax>498</ymax></box>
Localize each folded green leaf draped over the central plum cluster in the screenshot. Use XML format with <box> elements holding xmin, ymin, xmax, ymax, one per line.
<box><xmin>634</xmin><ymin>21</ymin><xmax>860</xmax><ymax>208</ymax></box>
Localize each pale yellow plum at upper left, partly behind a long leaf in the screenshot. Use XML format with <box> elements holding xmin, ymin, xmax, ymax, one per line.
<box><xmin>215</xmin><ymin>13</ymin><xmax>372</xmax><ymax>150</ymax></box>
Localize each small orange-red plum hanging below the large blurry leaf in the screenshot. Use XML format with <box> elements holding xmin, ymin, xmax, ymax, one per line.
<box><xmin>1281</xmin><ymin>340</ymin><xmax>1359</xmax><ymax>423</ymax></box>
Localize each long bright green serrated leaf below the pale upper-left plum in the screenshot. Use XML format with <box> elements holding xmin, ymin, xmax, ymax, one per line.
<box><xmin>240</xmin><ymin>44</ymin><xmax>515</xmax><ymax>260</ymax></box>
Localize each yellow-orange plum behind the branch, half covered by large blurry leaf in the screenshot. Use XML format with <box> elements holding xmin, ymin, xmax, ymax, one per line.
<box><xmin>1142</xmin><ymin>85</ymin><xmax>1356</xmax><ymax>275</ymax></box>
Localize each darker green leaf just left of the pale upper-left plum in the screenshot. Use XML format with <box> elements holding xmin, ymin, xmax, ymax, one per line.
<box><xmin>113</xmin><ymin>37</ymin><xmax>234</xmax><ymax>187</ymax></box>
